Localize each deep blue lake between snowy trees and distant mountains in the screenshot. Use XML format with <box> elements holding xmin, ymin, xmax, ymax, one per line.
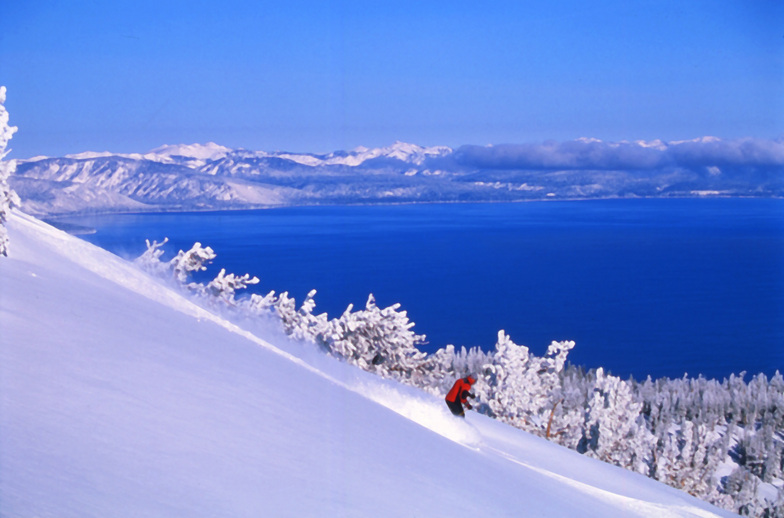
<box><xmin>59</xmin><ymin>199</ymin><xmax>784</xmax><ymax>378</ymax></box>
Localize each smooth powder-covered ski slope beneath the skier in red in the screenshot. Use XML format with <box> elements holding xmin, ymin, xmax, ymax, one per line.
<box><xmin>0</xmin><ymin>214</ymin><xmax>733</xmax><ymax>517</ymax></box>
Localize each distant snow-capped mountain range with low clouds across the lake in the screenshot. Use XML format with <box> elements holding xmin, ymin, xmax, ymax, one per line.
<box><xmin>10</xmin><ymin>137</ymin><xmax>784</xmax><ymax>216</ymax></box>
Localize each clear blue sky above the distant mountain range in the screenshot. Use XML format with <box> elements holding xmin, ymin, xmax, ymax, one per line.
<box><xmin>0</xmin><ymin>0</ymin><xmax>784</xmax><ymax>158</ymax></box>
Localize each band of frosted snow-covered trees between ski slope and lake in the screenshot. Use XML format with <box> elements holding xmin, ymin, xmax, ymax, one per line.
<box><xmin>137</xmin><ymin>240</ymin><xmax>784</xmax><ymax>518</ymax></box>
